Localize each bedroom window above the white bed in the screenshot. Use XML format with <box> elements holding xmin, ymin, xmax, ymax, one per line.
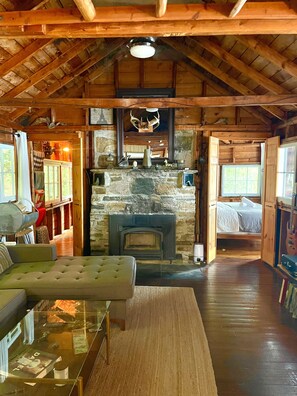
<box><xmin>221</xmin><ymin>165</ymin><xmax>261</xmax><ymax>197</ymax></box>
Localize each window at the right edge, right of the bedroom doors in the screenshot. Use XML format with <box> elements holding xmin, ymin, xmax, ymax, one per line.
<box><xmin>277</xmin><ymin>143</ymin><xmax>297</xmax><ymax>203</ymax></box>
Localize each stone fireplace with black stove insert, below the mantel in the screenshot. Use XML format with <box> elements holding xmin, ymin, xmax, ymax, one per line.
<box><xmin>90</xmin><ymin>168</ymin><xmax>195</xmax><ymax>262</ymax></box>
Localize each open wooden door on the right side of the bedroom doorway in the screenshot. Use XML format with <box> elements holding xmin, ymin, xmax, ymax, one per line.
<box><xmin>261</xmin><ymin>136</ymin><xmax>280</xmax><ymax>266</ymax></box>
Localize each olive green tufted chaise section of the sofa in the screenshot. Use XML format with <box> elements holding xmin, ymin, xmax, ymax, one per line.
<box><xmin>0</xmin><ymin>244</ymin><xmax>136</xmax><ymax>329</ymax></box>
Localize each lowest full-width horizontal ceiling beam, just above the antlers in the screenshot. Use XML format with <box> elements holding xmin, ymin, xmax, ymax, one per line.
<box><xmin>0</xmin><ymin>94</ymin><xmax>297</xmax><ymax>109</ymax></box>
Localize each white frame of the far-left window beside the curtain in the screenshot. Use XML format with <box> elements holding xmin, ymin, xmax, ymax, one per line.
<box><xmin>0</xmin><ymin>142</ymin><xmax>17</xmax><ymax>202</ymax></box>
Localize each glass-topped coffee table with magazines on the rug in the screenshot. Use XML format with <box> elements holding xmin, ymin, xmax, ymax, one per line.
<box><xmin>0</xmin><ymin>300</ymin><xmax>110</xmax><ymax>396</ymax></box>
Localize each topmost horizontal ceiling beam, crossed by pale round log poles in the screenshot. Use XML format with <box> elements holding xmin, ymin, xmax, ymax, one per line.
<box><xmin>0</xmin><ymin>0</ymin><xmax>297</xmax><ymax>26</ymax></box>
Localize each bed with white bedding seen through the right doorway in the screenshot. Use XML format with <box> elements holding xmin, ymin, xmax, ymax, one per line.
<box><xmin>217</xmin><ymin>198</ymin><xmax>262</xmax><ymax>237</ymax></box>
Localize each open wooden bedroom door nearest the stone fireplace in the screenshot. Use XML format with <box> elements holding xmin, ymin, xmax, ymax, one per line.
<box><xmin>205</xmin><ymin>136</ymin><xmax>219</xmax><ymax>263</ymax></box>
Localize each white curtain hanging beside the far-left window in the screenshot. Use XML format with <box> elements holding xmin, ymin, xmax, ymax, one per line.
<box><xmin>15</xmin><ymin>131</ymin><xmax>34</xmax><ymax>243</ymax></box>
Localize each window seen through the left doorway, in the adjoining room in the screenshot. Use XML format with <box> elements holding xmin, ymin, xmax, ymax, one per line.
<box><xmin>44</xmin><ymin>160</ymin><xmax>72</xmax><ymax>204</ymax></box>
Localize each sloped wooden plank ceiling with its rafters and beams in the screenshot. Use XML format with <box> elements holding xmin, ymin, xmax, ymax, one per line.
<box><xmin>0</xmin><ymin>0</ymin><xmax>297</xmax><ymax>135</ymax></box>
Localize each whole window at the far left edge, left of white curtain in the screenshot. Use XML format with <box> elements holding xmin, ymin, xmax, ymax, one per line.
<box><xmin>0</xmin><ymin>144</ymin><xmax>16</xmax><ymax>202</ymax></box>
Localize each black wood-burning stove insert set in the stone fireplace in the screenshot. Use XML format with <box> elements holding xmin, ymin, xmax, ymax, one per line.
<box><xmin>109</xmin><ymin>214</ymin><xmax>176</xmax><ymax>260</ymax></box>
